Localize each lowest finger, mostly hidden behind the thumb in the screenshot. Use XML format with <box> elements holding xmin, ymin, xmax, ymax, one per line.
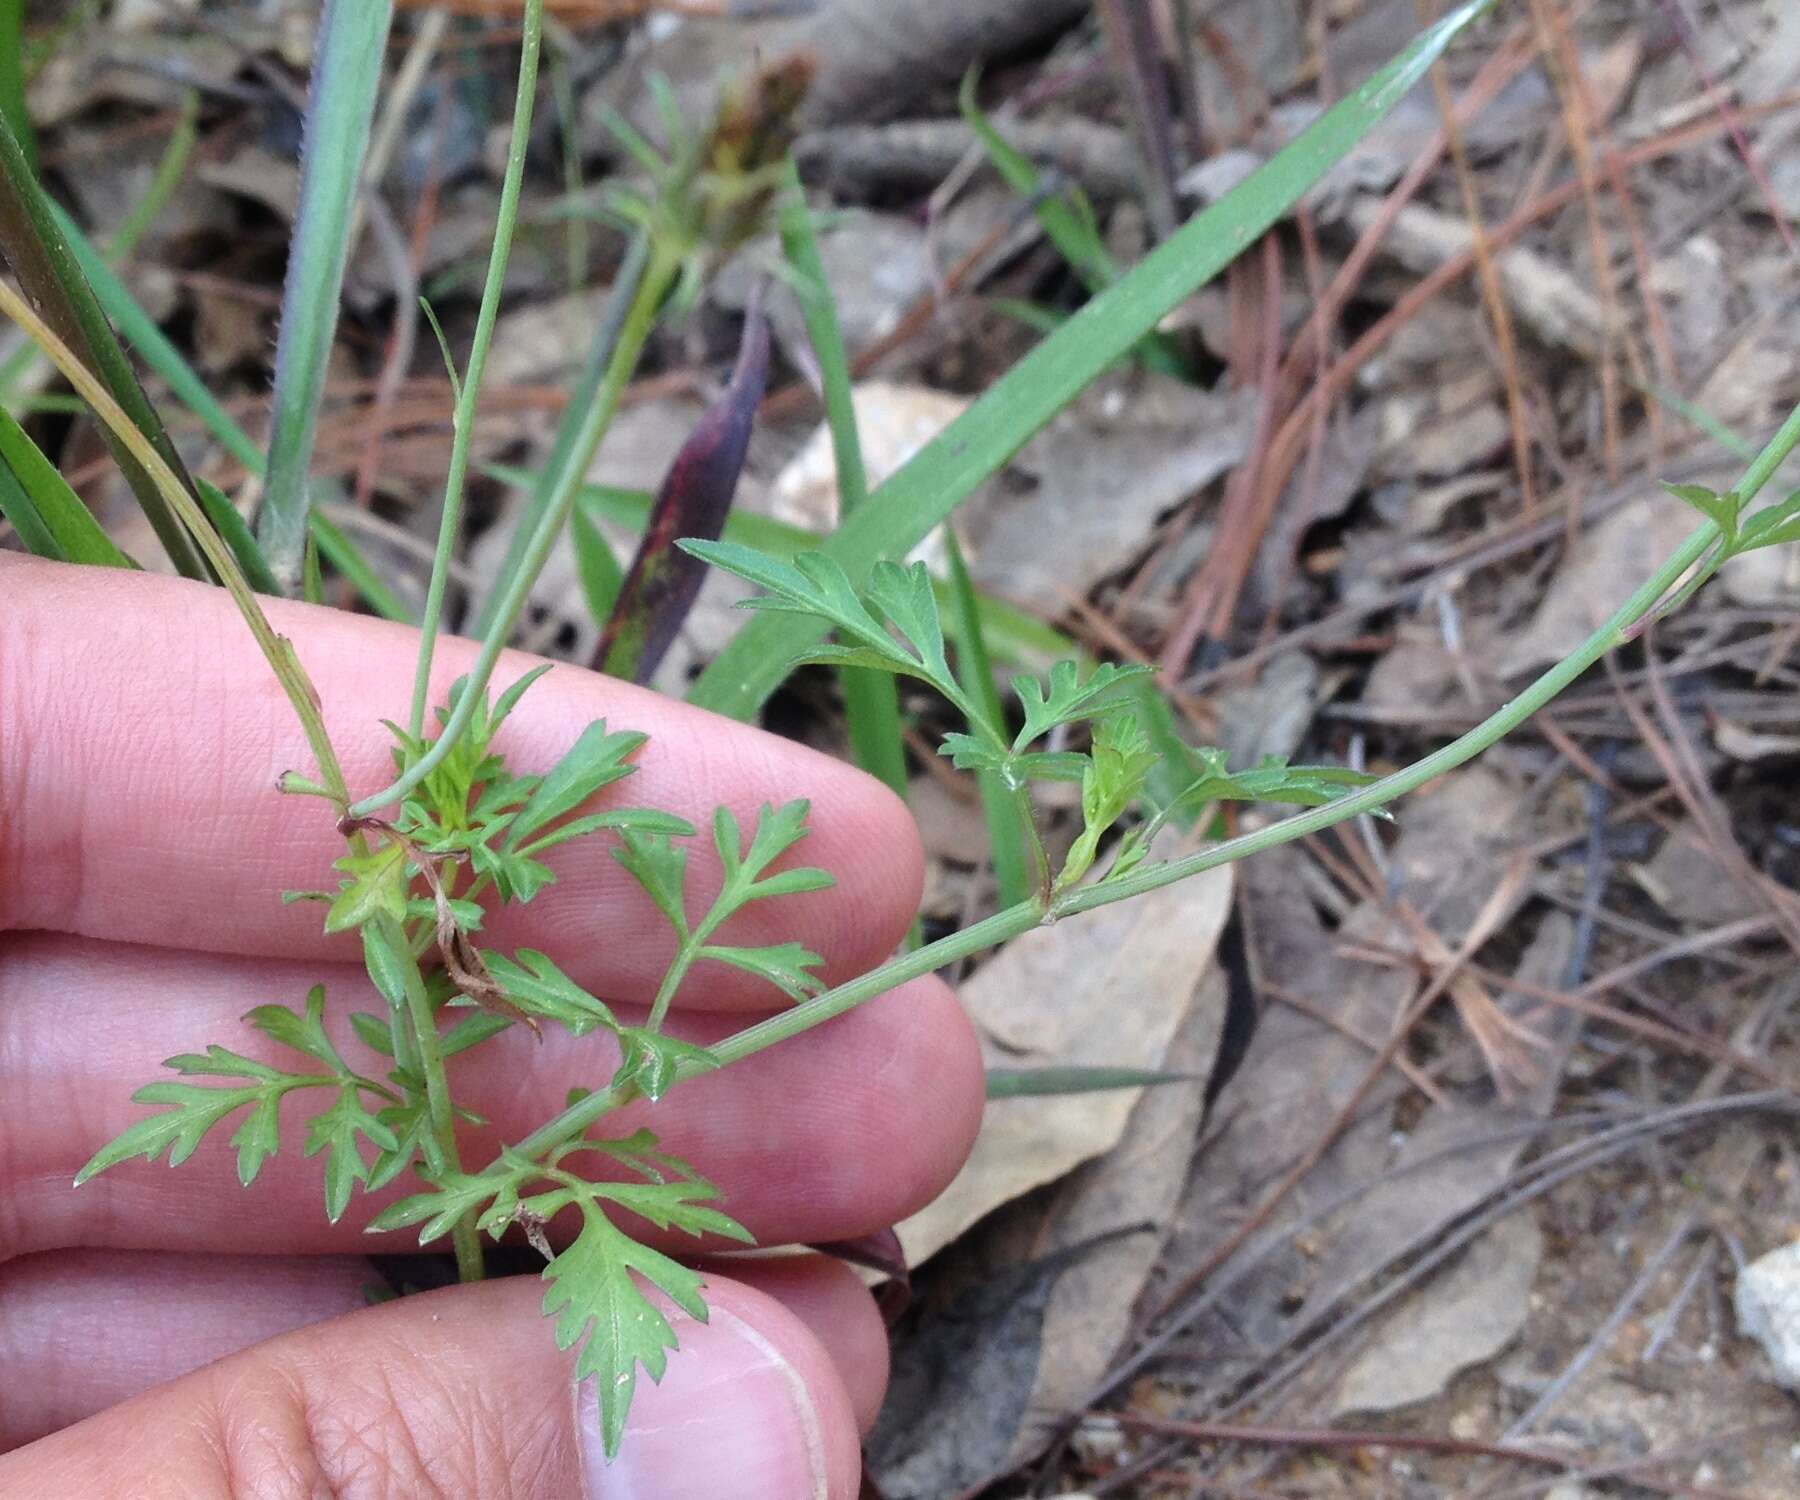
<box><xmin>0</xmin><ymin>1250</ymin><xmax>887</xmax><ymax>1451</ymax></box>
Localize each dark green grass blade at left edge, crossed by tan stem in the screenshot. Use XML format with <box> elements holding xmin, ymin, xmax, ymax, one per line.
<box><xmin>0</xmin><ymin>115</ymin><xmax>212</xmax><ymax>578</ymax></box>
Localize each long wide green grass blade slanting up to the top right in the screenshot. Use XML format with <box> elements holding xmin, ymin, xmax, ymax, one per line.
<box><xmin>689</xmin><ymin>0</ymin><xmax>1485</xmax><ymax>718</ymax></box>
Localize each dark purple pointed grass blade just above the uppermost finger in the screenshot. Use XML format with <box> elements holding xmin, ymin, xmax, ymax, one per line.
<box><xmin>594</xmin><ymin>297</ymin><xmax>769</xmax><ymax>682</ymax></box>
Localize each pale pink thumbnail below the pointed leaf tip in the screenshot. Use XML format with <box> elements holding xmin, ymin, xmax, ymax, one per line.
<box><xmin>576</xmin><ymin>1306</ymin><xmax>826</xmax><ymax>1500</ymax></box>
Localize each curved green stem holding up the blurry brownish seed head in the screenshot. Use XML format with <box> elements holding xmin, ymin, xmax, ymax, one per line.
<box><xmin>349</xmin><ymin>248</ymin><xmax>680</xmax><ymax>818</ymax></box>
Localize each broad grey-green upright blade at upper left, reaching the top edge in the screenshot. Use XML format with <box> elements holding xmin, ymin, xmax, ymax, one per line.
<box><xmin>257</xmin><ymin>0</ymin><xmax>394</xmax><ymax>592</ymax></box>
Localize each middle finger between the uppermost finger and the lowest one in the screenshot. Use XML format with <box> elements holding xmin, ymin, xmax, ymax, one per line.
<box><xmin>0</xmin><ymin>935</ymin><xmax>981</xmax><ymax>1255</ymax></box>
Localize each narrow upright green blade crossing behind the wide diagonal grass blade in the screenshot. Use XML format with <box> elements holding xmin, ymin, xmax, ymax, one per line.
<box><xmin>779</xmin><ymin>157</ymin><xmax>905</xmax><ymax>798</ymax></box>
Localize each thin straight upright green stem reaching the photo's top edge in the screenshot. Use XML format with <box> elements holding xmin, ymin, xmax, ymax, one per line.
<box><xmin>407</xmin><ymin>0</ymin><xmax>544</xmax><ymax>738</ymax></box>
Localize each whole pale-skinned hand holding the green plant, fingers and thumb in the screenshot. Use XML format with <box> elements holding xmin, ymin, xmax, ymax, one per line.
<box><xmin>0</xmin><ymin>555</ymin><xmax>981</xmax><ymax>1500</ymax></box>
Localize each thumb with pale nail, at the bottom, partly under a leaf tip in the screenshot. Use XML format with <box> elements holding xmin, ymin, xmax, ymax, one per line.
<box><xmin>0</xmin><ymin>1277</ymin><xmax>860</xmax><ymax>1500</ymax></box>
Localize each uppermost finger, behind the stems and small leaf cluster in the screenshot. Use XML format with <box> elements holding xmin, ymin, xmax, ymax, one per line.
<box><xmin>0</xmin><ymin>556</ymin><xmax>923</xmax><ymax>1007</ymax></box>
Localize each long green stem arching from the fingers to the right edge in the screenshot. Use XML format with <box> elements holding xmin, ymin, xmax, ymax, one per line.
<box><xmin>486</xmin><ymin>394</ymin><xmax>1800</xmax><ymax>1176</ymax></box>
